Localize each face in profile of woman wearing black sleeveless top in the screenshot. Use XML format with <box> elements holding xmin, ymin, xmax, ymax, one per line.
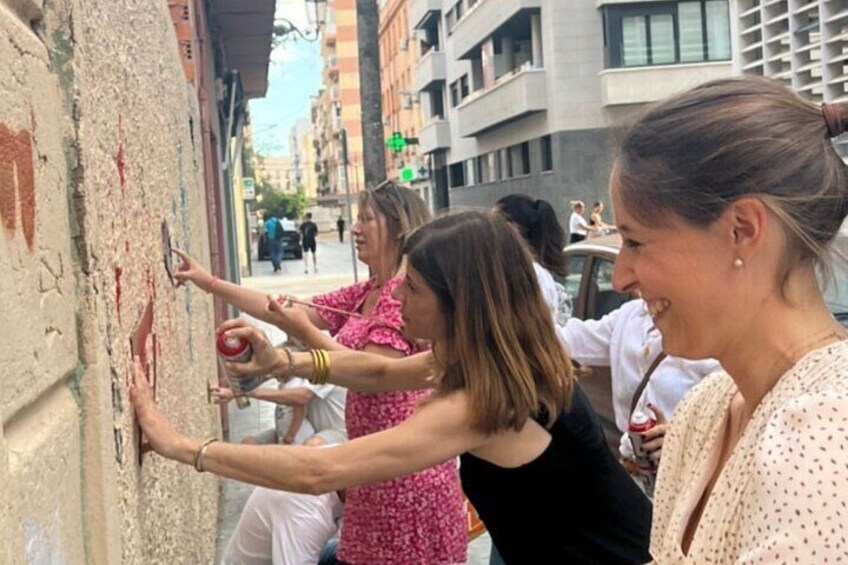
<box><xmin>394</xmin><ymin>265</ymin><xmax>446</xmax><ymax>342</ymax></box>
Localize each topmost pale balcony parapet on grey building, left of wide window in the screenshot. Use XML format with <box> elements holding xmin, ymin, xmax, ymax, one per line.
<box><xmin>451</xmin><ymin>0</ymin><xmax>540</xmax><ymax>59</ymax></box>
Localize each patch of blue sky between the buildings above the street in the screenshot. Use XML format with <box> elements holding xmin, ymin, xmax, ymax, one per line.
<box><xmin>250</xmin><ymin>0</ymin><xmax>321</xmax><ymax>155</ymax></box>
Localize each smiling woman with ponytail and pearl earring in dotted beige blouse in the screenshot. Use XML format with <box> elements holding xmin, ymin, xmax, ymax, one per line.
<box><xmin>610</xmin><ymin>77</ymin><xmax>848</xmax><ymax>564</ymax></box>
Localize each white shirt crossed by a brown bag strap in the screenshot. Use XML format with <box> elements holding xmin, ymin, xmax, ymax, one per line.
<box><xmin>557</xmin><ymin>299</ymin><xmax>721</xmax><ymax>457</ymax></box>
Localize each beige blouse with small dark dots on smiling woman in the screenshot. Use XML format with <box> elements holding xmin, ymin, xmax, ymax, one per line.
<box><xmin>651</xmin><ymin>341</ymin><xmax>848</xmax><ymax>565</ymax></box>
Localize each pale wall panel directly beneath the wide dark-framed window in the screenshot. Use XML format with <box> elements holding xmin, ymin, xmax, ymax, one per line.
<box><xmin>601</xmin><ymin>61</ymin><xmax>733</xmax><ymax>106</ymax></box>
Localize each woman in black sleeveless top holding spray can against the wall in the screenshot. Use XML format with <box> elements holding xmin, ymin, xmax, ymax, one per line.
<box><xmin>130</xmin><ymin>212</ymin><xmax>650</xmax><ymax>564</ymax></box>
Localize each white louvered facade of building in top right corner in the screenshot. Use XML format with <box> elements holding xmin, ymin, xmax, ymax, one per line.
<box><xmin>735</xmin><ymin>0</ymin><xmax>848</xmax><ymax>102</ymax></box>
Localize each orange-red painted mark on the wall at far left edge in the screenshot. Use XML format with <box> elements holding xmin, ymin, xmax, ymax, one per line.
<box><xmin>0</xmin><ymin>124</ymin><xmax>35</xmax><ymax>251</ymax></box>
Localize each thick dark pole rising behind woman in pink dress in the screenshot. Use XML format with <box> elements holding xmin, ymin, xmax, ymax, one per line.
<box><xmin>356</xmin><ymin>0</ymin><xmax>386</xmax><ymax>189</ymax></box>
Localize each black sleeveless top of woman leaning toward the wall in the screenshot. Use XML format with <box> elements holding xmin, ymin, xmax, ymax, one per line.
<box><xmin>459</xmin><ymin>387</ymin><xmax>651</xmax><ymax>565</ymax></box>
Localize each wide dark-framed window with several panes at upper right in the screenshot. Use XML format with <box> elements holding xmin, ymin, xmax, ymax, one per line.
<box><xmin>604</xmin><ymin>0</ymin><xmax>730</xmax><ymax>68</ymax></box>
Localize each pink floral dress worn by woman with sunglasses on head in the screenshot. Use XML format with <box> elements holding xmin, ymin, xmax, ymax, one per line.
<box><xmin>312</xmin><ymin>276</ymin><xmax>468</xmax><ymax>565</ymax></box>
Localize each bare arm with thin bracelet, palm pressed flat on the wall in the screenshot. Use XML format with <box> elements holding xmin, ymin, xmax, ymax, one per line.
<box><xmin>129</xmin><ymin>358</ymin><xmax>480</xmax><ymax>494</ymax></box>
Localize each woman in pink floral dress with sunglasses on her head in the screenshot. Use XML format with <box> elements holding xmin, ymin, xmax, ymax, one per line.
<box><xmin>275</xmin><ymin>184</ymin><xmax>468</xmax><ymax>565</ymax></box>
